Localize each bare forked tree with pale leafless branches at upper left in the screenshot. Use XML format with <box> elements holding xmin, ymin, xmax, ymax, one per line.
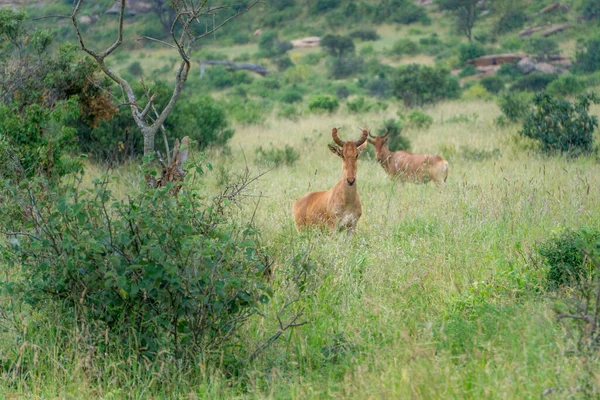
<box><xmin>71</xmin><ymin>0</ymin><xmax>260</xmax><ymax>156</ymax></box>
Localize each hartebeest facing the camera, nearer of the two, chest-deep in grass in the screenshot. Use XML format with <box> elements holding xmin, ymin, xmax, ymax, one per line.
<box><xmin>292</xmin><ymin>128</ymin><xmax>368</xmax><ymax>231</ymax></box>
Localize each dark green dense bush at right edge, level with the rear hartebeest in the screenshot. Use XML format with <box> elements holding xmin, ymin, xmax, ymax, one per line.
<box><xmin>519</xmin><ymin>93</ymin><xmax>600</xmax><ymax>155</ymax></box>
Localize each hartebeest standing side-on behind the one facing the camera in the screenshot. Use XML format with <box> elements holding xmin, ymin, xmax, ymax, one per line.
<box><xmin>369</xmin><ymin>132</ymin><xmax>448</xmax><ymax>185</ymax></box>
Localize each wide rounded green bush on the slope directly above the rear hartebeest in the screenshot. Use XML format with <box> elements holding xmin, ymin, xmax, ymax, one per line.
<box><xmin>392</xmin><ymin>64</ymin><xmax>460</xmax><ymax>107</ymax></box>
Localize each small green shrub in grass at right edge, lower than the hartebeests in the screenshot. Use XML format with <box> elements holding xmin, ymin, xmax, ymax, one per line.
<box><xmin>537</xmin><ymin>230</ymin><xmax>600</xmax><ymax>288</ymax></box>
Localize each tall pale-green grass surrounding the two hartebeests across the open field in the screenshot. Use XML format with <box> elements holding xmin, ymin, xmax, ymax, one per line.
<box><xmin>0</xmin><ymin>102</ymin><xmax>600</xmax><ymax>399</ymax></box>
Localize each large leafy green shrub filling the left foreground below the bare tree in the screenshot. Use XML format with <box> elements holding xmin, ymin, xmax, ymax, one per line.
<box><xmin>0</xmin><ymin>180</ymin><xmax>270</xmax><ymax>359</ymax></box>
